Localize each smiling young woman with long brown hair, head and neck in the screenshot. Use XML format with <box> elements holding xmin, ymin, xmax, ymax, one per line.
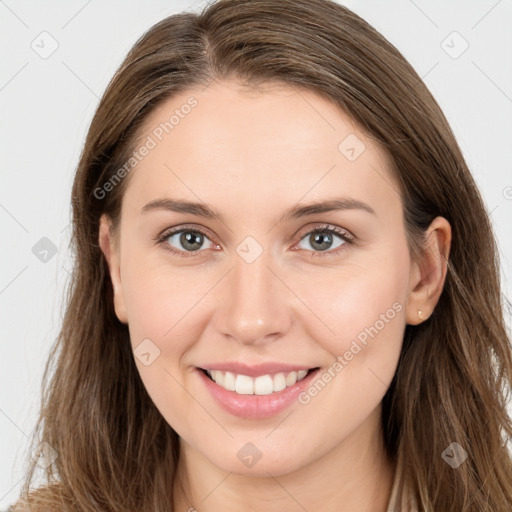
<box><xmin>11</xmin><ymin>0</ymin><xmax>512</xmax><ymax>512</ymax></box>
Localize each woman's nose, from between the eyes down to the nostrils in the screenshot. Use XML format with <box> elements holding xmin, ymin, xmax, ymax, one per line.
<box><xmin>212</xmin><ymin>252</ymin><xmax>292</xmax><ymax>345</ymax></box>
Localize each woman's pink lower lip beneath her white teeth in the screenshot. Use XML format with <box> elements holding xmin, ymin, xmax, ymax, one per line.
<box><xmin>196</xmin><ymin>368</ymin><xmax>320</xmax><ymax>419</ymax></box>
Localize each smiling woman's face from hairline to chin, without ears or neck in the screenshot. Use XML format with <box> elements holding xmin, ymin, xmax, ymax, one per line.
<box><xmin>102</xmin><ymin>81</ymin><xmax>420</xmax><ymax>475</ymax></box>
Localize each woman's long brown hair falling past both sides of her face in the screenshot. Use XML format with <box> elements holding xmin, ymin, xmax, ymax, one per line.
<box><xmin>14</xmin><ymin>0</ymin><xmax>512</xmax><ymax>512</ymax></box>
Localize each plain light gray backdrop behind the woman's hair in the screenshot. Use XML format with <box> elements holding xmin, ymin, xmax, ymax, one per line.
<box><xmin>0</xmin><ymin>0</ymin><xmax>512</xmax><ymax>508</ymax></box>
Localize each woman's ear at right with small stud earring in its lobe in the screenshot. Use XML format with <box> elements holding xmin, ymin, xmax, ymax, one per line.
<box><xmin>406</xmin><ymin>217</ymin><xmax>452</xmax><ymax>325</ymax></box>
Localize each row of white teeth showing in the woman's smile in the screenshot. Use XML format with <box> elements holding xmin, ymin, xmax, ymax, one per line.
<box><xmin>206</xmin><ymin>370</ymin><xmax>308</xmax><ymax>395</ymax></box>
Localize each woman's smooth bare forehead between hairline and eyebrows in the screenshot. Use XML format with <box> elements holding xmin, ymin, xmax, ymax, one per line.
<box><xmin>121</xmin><ymin>81</ymin><xmax>400</xmax><ymax>222</ymax></box>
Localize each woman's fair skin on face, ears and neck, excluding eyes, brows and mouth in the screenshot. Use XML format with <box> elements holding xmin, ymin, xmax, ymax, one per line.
<box><xmin>99</xmin><ymin>80</ymin><xmax>451</xmax><ymax>512</ymax></box>
